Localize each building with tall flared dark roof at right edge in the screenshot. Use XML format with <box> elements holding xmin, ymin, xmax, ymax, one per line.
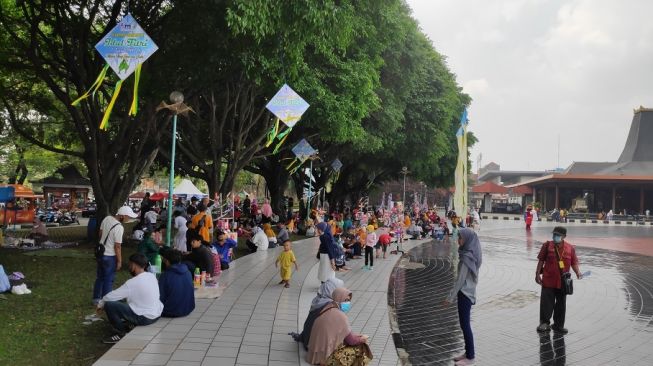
<box><xmin>508</xmin><ymin>107</ymin><xmax>653</xmax><ymax>214</ymax></box>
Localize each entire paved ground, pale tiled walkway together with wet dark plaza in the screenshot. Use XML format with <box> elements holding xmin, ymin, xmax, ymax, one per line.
<box><xmin>95</xmin><ymin>220</ymin><xmax>653</xmax><ymax>366</ymax></box>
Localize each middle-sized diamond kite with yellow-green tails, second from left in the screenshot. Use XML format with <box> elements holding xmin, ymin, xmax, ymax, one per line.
<box><xmin>265</xmin><ymin>84</ymin><xmax>310</xmax><ymax>153</ymax></box>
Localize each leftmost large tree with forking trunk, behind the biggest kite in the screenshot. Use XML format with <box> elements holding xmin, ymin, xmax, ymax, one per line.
<box><xmin>0</xmin><ymin>0</ymin><xmax>174</xmax><ymax>217</ymax></box>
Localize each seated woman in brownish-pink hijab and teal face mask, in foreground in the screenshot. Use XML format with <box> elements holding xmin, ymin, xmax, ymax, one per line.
<box><xmin>306</xmin><ymin>287</ymin><xmax>372</xmax><ymax>365</ymax></box>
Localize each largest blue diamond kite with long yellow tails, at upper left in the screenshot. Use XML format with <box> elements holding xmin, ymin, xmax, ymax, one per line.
<box><xmin>71</xmin><ymin>13</ymin><xmax>159</xmax><ymax>130</ymax></box>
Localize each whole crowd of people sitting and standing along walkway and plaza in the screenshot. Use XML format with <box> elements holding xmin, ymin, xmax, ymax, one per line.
<box><xmin>93</xmin><ymin>193</ymin><xmax>582</xmax><ymax>365</ymax></box>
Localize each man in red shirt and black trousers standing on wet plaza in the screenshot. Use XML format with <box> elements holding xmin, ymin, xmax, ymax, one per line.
<box><xmin>535</xmin><ymin>226</ymin><xmax>582</xmax><ymax>334</ymax></box>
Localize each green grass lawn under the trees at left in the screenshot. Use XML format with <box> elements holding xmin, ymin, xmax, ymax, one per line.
<box><xmin>0</xmin><ymin>226</ymin><xmax>262</xmax><ymax>366</ymax></box>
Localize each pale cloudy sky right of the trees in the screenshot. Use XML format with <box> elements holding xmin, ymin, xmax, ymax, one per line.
<box><xmin>407</xmin><ymin>0</ymin><xmax>653</xmax><ymax>172</ymax></box>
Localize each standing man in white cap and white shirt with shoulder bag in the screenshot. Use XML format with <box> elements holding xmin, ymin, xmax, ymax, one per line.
<box><xmin>93</xmin><ymin>206</ymin><xmax>138</xmax><ymax>305</ymax></box>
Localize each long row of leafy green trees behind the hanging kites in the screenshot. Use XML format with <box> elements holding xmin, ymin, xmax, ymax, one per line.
<box><xmin>0</xmin><ymin>0</ymin><xmax>474</xmax><ymax>220</ymax></box>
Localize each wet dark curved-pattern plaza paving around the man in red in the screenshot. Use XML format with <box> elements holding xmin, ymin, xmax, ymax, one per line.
<box><xmin>388</xmin><ymin>224</ymin><xmax>653</xmax><ymax>365</ymax></box>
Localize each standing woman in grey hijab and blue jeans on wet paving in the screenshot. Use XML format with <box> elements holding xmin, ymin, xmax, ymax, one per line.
<box><xmin>445</xmin><ymin>228</ymin><xmax>483</xmax><ymax>366</ymax></box>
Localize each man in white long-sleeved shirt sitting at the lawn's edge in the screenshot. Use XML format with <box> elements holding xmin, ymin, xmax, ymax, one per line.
<box><xmin>96</xmin><ymin>253</ymin><xmax>163</xmax><ymax>344</ymax></box>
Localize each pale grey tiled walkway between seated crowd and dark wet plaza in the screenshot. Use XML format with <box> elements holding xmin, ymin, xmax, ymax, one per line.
<box><xmin>94</xmin><ymin>234</ymin><xmax>424</xmax><ymax>366</ymax></box>
